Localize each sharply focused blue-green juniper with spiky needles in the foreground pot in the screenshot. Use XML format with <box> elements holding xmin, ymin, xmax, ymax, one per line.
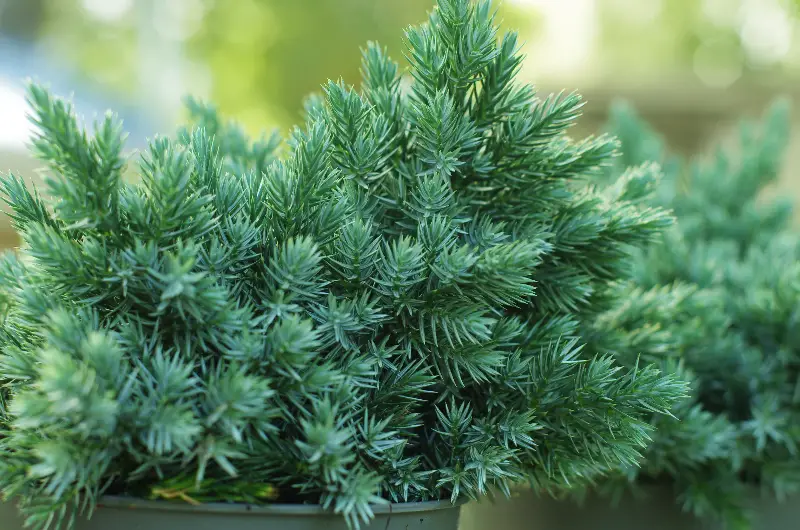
<box><xmin>0</xmin><ymin>0</ymin><xmax>685</xmax><ymax>528</ymax></box>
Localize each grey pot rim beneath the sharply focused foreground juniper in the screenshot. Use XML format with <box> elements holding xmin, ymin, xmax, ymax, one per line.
<box><xmin>97</xmin><ymin>496</ymin><xmax>466</xmax><ymax>517</ymax></box>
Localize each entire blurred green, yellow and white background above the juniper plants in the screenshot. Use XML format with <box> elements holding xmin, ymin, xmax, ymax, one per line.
<box><xmin>0</xmin><ymin>0</ymin><xmax>800</xmax><ymax>244</ymax></box>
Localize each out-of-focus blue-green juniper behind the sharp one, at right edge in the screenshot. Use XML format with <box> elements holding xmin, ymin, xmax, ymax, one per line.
<box><xmin>580</xmin><ymin>101</ymin><xmax>800</xmax><ymax>528</ymax></box>
